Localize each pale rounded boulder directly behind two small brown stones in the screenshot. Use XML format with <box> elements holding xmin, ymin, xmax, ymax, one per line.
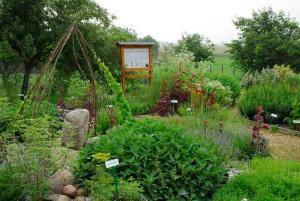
<box><xmin>51</xmin><ymin>169</ymin><xmax>74</xmax><ymax>194</ymax></box>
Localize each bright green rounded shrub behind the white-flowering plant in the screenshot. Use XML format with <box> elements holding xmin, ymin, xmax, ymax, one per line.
<box><xmin>209</xmin><ymin>74</ymin><xmax>241</xmax><ymax>100</ymax></box>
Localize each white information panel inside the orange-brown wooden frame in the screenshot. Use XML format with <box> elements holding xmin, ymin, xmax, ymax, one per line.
<box><xmin>124</xmin><ymin>48</ymin><xmax>149</xmax><ymax>68</ymax></box>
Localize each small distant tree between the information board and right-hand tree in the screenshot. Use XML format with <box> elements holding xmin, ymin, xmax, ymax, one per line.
<box><xmin>176</xmin><ymin>34</ymin><xmax>214</xmax><ymax>62</ymax></box>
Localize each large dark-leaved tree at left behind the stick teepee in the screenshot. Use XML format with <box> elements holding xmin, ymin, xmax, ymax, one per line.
<box><xmin>0</xmin><ymin>0</ymin><xmax>111</xmax><ymax>97</ymax></box>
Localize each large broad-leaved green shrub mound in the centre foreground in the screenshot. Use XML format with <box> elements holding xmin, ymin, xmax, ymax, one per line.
<box><xmin>74</xmin><ymin>119</ymin><xmax>226</xmax><ymax>200</ymax></box>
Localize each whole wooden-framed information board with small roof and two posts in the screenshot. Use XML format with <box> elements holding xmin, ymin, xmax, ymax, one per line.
<box><xmin>117</xmin><ymin>42</ymin><xmax>154</xmax><ymax>94</ymax></box>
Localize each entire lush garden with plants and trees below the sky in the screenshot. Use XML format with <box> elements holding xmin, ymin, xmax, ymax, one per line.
<box><xmin>0</xmin><ymin>0</ymin><xmax>300</xmax><ymax>201</ymax></box>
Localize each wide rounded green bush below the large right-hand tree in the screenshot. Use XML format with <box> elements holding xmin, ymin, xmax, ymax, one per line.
<box><xmin>237</xmin><ymin>83</ymin><xmax>299</xmax><ymax>121</ymax></box>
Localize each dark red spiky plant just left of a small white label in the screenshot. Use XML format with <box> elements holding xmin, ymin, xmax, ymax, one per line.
<box><xmin>157</xmin><ymin>80</ymin><xmax>170</xmax><ymax>117</ymax></box>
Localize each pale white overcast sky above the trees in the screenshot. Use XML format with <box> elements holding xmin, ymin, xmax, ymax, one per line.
<box><xmin>96</xmin><ymin>0</ymin><xmax>300</xmax><ymax>43</ymax></box>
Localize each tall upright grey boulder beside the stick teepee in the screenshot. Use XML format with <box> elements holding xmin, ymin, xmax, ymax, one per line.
<box><xmin>62</xmin><ymin>109</ymin><xmax>90</xmax><ymax>150</ymax></box>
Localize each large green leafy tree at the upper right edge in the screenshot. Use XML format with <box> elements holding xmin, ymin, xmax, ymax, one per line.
<box><xmin>227</xmin><ymin>8</ymin><xmax>300</xmax><ymax>71</ymax></box>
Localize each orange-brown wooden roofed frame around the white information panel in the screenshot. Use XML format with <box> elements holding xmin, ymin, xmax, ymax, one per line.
<box><xmin>117</xmin><ymin>42</ymin><xmax>154</xmax><ymax>94</ymax></box>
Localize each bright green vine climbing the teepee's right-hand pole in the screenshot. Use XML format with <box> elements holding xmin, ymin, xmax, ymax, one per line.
<box><xmin>93</xmin><ymin>53</ymin><xmax>133</xmax><ymax>122</ymax></box>
